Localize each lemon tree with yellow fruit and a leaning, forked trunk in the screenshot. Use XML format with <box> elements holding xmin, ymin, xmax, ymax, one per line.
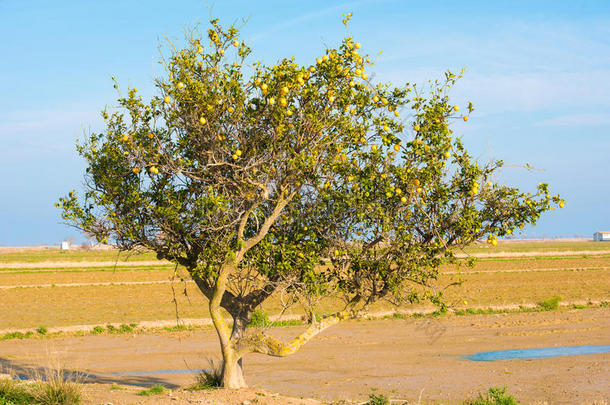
<box><xmin>57</xmin><ymin>16</ymin><xmax>563</xmax><ymax>388</ymax></box>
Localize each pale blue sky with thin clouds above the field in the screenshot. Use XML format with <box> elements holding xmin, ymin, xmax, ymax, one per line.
<box><xmin>0</xmin><ymin>0</ymin><xmax>610</xmax><ymax>246</ymax></box>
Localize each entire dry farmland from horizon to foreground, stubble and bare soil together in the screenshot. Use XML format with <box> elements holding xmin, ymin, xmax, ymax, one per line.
<box><xmin>0</xmin><ymin>241</ymin><xmax>610</xmax><ymax>404</ymax></box>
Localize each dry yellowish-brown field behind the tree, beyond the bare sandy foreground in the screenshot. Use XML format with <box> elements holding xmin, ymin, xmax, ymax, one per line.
<box><xmin>0</xmin><ymin>242</ymin><xmax>610</xmax><ymax>331</ymax></box>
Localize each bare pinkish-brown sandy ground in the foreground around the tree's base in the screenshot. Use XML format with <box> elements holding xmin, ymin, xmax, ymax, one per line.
<box><xmin>0</xmin><ymin>308</ymin><xmax>610</xmax><ymax>405</ymax></box>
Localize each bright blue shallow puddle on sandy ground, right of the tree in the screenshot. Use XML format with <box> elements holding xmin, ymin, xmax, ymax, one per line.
<box><xmin>465</xmin><ymin>345</ymin><xmax>610</xmax><ymax>361</ymax></box>
